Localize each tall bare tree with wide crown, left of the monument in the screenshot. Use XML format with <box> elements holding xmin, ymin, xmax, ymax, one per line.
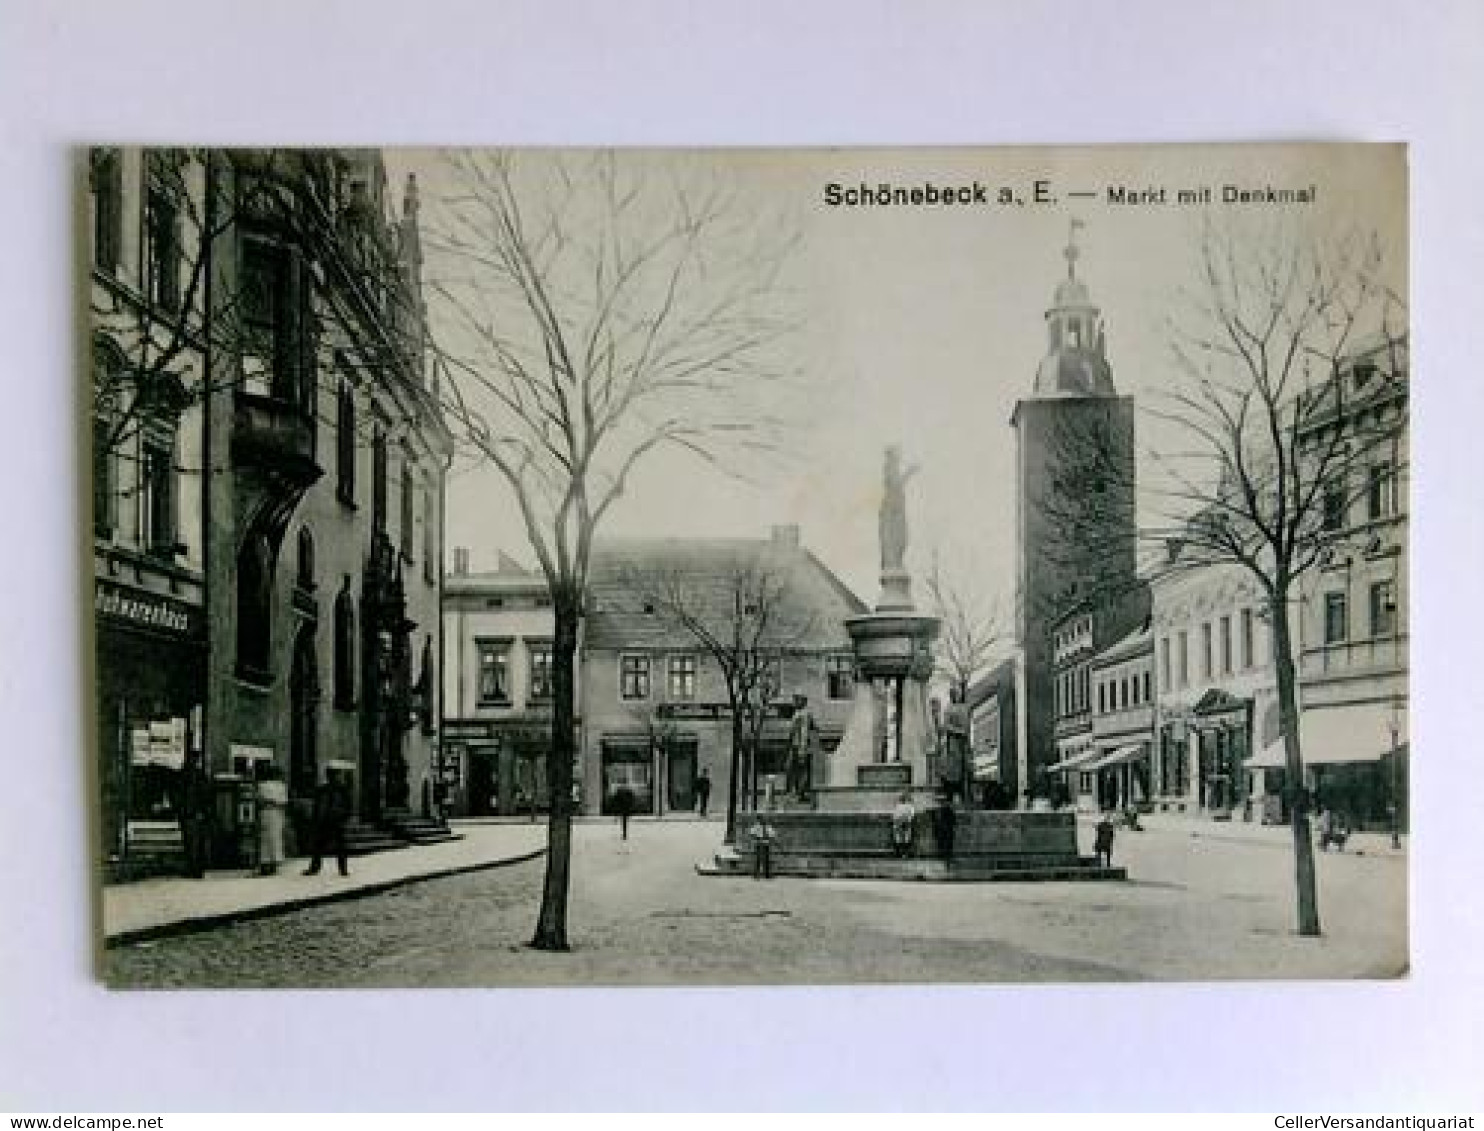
<box><xmin>427</xmin><ymin>151</ymin><xmax>789</xmax><ymax>950</ymax></box>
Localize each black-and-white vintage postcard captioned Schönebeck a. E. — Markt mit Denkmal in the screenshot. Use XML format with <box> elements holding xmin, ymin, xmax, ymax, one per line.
<box><xmin>79</xmin><ymin>144</ymin><xmax>1410</xmax><ymax>989</ymax></box>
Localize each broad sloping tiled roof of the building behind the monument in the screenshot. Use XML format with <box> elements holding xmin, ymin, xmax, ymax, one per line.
<box><xmin>583</xmin><ymin>539</ymin><xmax>867</xmax><ymax>652</ymax></box>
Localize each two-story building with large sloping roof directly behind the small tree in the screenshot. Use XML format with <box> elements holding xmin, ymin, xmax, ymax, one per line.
<box><xmin>580</xmin><ymin>527</ymin><xmax>867</xmax><ymax>813</ymax></box>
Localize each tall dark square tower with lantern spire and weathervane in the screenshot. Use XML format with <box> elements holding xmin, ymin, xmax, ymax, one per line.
<box><xmin>1008</xmin><ymin>220</ymin><xmax>1135</xmax><ymax>794</ymax></box>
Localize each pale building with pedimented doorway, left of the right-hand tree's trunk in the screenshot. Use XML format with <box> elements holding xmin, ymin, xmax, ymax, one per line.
<box><xmin>1152</xmin><ymin>542</ymin><xmax>1282</xmax><ymax>821</ymax></box>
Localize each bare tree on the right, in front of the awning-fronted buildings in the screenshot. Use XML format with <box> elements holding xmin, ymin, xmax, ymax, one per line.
<box><xmin>1058</xmin><ymin>221</ymin><xmax>1407</xmax><ymax>935</ymax></box>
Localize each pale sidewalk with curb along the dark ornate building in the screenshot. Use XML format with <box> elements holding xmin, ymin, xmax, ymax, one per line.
<box><xmin>102</xmin><ymin>821</ymin><xmax>546</xmax><ymax>947</ymax></box>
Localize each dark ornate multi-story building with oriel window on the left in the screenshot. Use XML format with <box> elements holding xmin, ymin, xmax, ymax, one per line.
<box><xmin>92</xmin><ymin>150</ymin><xmax>451</xmax><ymax>856</ymax></box>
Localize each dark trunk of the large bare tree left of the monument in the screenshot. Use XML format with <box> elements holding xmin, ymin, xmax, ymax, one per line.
<box><xmin>531</xmin><ymin>589</ymin><xmax>582</xmax><ymax>950</ymax></box>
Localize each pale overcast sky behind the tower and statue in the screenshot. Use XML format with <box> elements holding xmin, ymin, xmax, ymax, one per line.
<box><xmin>389</xmin><ymin>145</ymin><xmax>1405</xmax><ymax>617</ymax></box>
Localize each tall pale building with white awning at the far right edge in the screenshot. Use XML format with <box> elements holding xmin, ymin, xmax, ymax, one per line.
<box><xmin>1297</xmin><ymin>334</ymin><xmax>1410</xmax><ymax>827</ymax></box>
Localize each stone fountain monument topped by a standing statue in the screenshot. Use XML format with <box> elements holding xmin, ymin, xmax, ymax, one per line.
<box><xmin>700</xmin><ymin>447</ymin><xmax>1125</xmax><ymax>880</ymax></box>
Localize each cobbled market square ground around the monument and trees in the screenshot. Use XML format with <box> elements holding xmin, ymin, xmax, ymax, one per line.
<box><xmin>105</xmin><ymin>822</ymin><xmax>1407</xmax><ymax>987</ymax></box>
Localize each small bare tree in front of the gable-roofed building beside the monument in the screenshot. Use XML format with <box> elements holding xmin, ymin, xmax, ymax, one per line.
<box><xmin>622</xmin><ymin>552</ymin><xmax>813</xmax><ymax>845</ymax></box>
